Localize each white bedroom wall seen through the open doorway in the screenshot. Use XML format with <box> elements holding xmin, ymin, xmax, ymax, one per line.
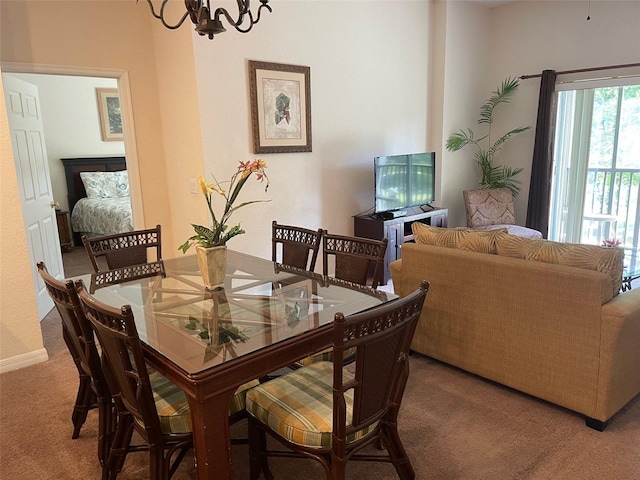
<box><xmin>10</xmin><ymin>73</ymin><xmax>124</xmax><ymax>210</ymax></box>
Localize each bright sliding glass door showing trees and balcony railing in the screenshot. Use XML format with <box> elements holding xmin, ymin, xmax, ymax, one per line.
<box><xmin>549</xmin><ymin>78</ymin><xmax>640</xmax><ymax>269</ymax></box>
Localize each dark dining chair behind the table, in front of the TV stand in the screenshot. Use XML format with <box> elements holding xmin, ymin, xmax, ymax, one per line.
<box><xmin>322</xmin><ymin>230</ymin><xmax>388</xmax><ymax>288</ymax></box>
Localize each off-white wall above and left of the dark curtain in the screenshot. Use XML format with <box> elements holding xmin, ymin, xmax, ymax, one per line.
<box><xmin>485</xmin><ymin>0</ymin><xmax>640</xmax><ymax>223</ymax></box>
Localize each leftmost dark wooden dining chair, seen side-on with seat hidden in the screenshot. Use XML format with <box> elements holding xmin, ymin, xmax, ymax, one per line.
<box><xmin>37</xmin><ymin>262</ymin><xmax>116</xmax><ymax>479</ymax></box>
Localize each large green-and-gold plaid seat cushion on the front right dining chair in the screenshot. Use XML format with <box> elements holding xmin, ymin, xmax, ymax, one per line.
<box><xmin>246</xmin><ymin>362</ymin><xmax>377</xmax><ymax>448</ymax></box>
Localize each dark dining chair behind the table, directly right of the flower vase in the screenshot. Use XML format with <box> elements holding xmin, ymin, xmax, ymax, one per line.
<box><xmin>271</xmin><ymin>220</ymin><xmax>322</xmax><ymax>272</ymax></box>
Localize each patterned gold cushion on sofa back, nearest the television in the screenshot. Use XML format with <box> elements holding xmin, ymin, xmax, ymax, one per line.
<box><xmin>411</xmin><ymin>222</ymin><xmax>507</xmax><ymax>253</ymax></box>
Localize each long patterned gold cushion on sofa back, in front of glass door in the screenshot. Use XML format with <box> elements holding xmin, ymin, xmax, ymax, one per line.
<box><xmin>496</xmin><ymin>235</ymin><xmax>624</xmax><ymax>296</ymax></box>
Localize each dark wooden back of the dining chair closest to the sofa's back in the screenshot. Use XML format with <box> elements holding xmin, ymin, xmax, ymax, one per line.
<box><xmin>331</xmin><ymin>281</ymin><xmax>429</xmax><ymax>478</ymax></box>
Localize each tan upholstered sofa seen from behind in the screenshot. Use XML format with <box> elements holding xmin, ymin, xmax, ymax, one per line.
<box><xmin>390</xmin><ymin>227</ymin><xmax>640</xmax><ymax>430</ymax></box>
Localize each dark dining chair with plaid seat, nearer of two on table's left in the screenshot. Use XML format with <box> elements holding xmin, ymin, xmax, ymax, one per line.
<box><xmin>75</xmin><ymin>280</ymin><xmax>258</xmax><ymax>480</ymax></box>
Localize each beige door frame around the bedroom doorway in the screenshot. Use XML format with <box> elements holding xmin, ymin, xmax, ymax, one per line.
<box><xmin>0</xmin><ymin>62</ymin><xmax>144</xmax><ymax>229</ymax></box>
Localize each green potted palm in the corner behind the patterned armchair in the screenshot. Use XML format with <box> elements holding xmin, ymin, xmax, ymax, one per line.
<box><xmin>445</xmin><ymin>78</ymin><xmax>531</xmax><ymax>196</ymax></box>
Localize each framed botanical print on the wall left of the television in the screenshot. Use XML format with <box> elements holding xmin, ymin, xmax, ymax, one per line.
<box><xmin>249</xmin><ymin>60</ymin><xmax>311</xmax><ymax>153</ymax></box>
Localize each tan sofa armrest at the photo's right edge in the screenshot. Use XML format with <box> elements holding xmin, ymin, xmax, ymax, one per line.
<box><xmin>596</xmin><ymin>288</ymin><xmax>640</xmax><ymax>420</ymax></box>
